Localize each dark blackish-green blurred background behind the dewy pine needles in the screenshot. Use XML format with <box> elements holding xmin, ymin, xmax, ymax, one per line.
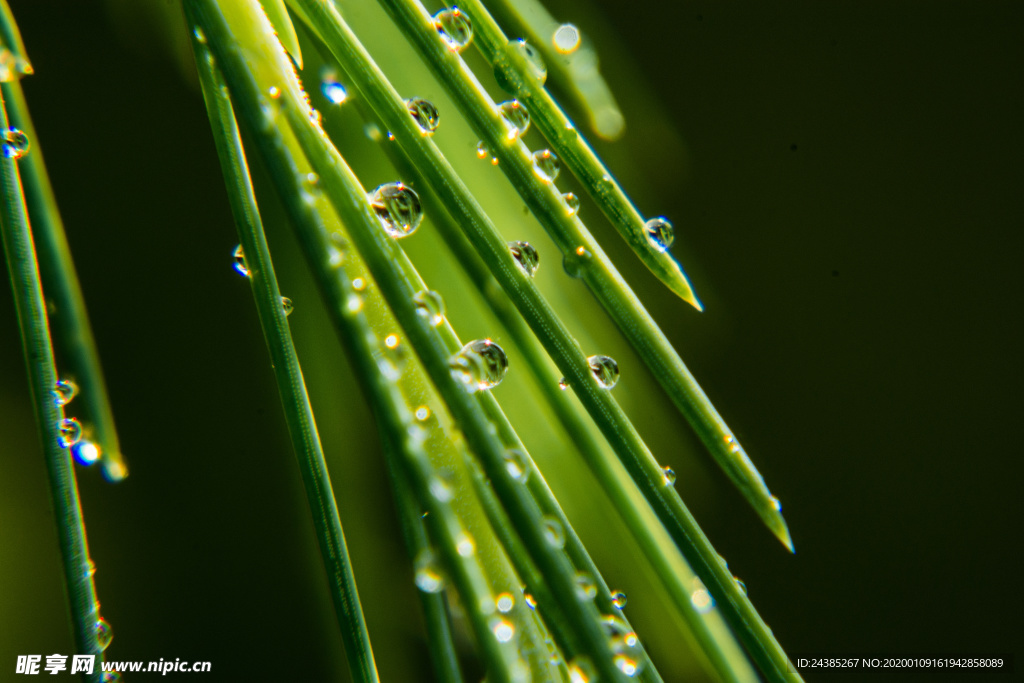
<box><xmin>0</xmin><ymin>0</ymin><xmax>1024</xmax><ymax>681</ymax></box>
